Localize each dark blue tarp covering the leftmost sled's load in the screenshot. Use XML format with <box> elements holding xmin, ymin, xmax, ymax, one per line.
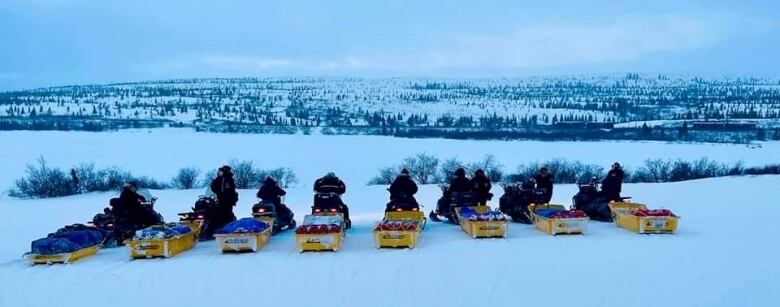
<box><xmin>31</xmin><ymin>230</ymin><xmax>103</xmax><ymax>255</ymax></box>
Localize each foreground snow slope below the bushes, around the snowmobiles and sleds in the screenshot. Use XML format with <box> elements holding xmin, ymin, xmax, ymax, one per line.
<box><xmin>0</xmin><ymin>176</ymin><xmax>780</xmax><ymax>307</ymax></box>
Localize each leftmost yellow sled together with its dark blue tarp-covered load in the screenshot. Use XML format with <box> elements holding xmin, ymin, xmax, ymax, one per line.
<box><xmin>26</xmin><ymin>224</ymin><xmax>106</xmax><ymax>265</ymax></box>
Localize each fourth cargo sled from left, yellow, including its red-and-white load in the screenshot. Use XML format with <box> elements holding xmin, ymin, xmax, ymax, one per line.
<box><xmin>295</xmin><ymin>212</ymin><xmax>345</xmax><ymax>253</ymax></box>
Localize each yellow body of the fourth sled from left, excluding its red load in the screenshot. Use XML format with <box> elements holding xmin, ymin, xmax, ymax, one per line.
<box><xmin>295</xmin><ymin>212</ymin><xmax>345</xmax><ymax>253</ymax></box>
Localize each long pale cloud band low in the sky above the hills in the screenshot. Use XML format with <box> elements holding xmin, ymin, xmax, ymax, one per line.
<box><xmin>147</xmin><ymin>14</ymin><xmax>775</xmax><ymax>74</ymax></box>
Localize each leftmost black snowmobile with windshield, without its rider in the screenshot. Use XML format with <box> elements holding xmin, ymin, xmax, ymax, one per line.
<box><xmin>88</xmin><ymin>189</ymin><xmax>163</xmax><ymax>247</ymax></box>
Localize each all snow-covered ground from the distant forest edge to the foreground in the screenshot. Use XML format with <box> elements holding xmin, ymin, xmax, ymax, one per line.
<box><xmin>0</xmin><ymin>130</ymin><xmax>780</xmax><ymax>307</ymax></box>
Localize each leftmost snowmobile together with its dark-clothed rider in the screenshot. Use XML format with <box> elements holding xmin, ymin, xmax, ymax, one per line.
<box><xmin>89</xmin><ymin>184</ymin><xmax>163</xmax><ymax>247</ymax></box>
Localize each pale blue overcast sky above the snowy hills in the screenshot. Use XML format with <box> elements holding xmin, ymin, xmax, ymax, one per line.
<box><xmin>0</xmin><ymin>0</ymin><xmax>780</xmax><ymax>91</ymax></box>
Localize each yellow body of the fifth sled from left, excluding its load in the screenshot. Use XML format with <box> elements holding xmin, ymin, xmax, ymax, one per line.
<box><xmin>374</xmin><ymin>211</ymin><xmax>425</xmax><ymax>248</ymax></box>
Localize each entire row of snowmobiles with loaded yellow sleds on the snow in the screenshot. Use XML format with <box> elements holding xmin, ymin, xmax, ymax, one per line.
<box><xmin>28</xmin><ymin>182</ymin><xmax>679</xmax><ymax>264</ymax></box>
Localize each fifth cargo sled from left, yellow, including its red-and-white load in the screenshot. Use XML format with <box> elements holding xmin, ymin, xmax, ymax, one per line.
<box><xmin>374</xmin><ymin>209</ymin><xmax>426</xmax><ymax>248</ymax></box>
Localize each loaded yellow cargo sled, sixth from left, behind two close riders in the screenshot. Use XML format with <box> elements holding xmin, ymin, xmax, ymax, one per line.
<box><xmin>456</xmin><ymin>206</ymin><xmax>507</xmax><ymax>239</ymax></box>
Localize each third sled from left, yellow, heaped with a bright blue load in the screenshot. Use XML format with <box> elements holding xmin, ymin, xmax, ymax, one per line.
<box><xmin>214</xmin><ymin>217</ymin><xmax>272</xmax><ymax>253</ymax></box>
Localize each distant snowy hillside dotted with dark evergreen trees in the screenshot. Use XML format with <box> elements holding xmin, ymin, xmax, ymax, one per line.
<box><xmin>0</xmin><ymin>73</ymin><xmax>780</xmax><ymax>142</ymax></box>
